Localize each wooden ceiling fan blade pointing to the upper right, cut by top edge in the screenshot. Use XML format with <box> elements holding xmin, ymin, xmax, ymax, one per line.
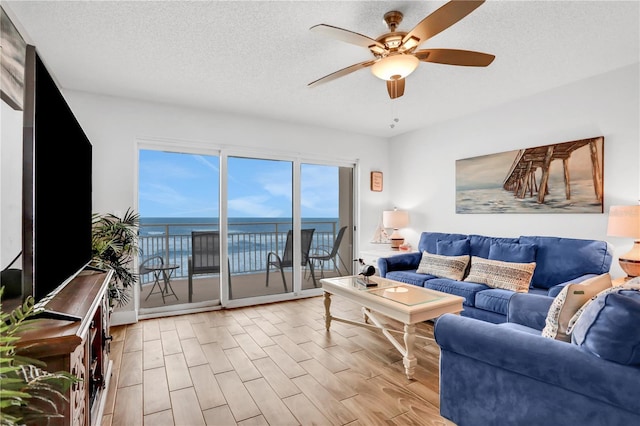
<box><xmin>402</xmin><ymin>0</ymin><xmax>484</xmax><ymax>47</ymax></box>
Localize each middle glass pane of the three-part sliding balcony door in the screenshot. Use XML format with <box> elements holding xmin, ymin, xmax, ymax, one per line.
<box><xmin>226</xmin><ymin>156</ymin><xmax>300</xmax><ymax>300</ymax></box>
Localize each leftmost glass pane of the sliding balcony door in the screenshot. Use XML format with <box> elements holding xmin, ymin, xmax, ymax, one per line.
<box><xmin>138</xmin><ymin>149</ymin><xmax>220</xmax><ymax>313</ymax></box>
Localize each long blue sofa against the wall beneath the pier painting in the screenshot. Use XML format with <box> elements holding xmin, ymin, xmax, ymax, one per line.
<box><xmin>378</xmin><ymin>232</ymin><xmax>613</xmax><ymax>323</ymax></box>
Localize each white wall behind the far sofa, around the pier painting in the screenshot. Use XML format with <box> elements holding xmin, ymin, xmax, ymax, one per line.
<box><xmin>389</xmin><ymin>63</ymin><xmax>640</xmax><ymax>275</ymax></box>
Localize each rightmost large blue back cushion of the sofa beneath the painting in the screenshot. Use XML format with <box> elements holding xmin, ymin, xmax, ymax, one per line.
<box><xmin>520</xmin><ymin>236</ymin><xmax>612</xmax><ymax>288</ymax></box>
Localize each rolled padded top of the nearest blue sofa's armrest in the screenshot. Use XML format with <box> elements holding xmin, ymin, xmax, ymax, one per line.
<box><xmin>434</xmin><ymin>314</ymin><xmax>640</xmax><ymax>416</ymax></box>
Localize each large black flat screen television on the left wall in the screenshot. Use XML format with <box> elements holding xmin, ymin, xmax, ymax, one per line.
<box><xmin>15</xmin><ymin>46</ymin><xmax>92</xmax><ymax>309</ymax></box>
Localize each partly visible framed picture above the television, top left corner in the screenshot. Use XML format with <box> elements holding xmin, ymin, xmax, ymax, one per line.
<box><xmin>0</xmin><ymin>9</ymin><xmax>27</xmax><ymax>111</ymax></box>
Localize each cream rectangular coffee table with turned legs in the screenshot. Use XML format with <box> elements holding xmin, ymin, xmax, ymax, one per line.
<box><xmin>320</xmin><ymin>276</ymin><xmax>464</xmax><ymax>379</ymax></box>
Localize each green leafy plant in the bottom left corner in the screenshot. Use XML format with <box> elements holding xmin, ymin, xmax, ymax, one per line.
<box><xmin>0</xmin><ymin>287</ymin><xmax>80</xmax><ymax>426</ymax></box>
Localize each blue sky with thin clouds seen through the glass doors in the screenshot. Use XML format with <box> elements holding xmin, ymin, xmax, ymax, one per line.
<box><xmin>138</xmin><ymin>150</ymin><xmax>339</xmax><ymax>218</ymax></box>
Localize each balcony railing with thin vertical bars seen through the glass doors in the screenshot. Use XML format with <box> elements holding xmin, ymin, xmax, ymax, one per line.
<box><xmin>138</xmin><ymin>220</ymin><xmax>338</xmax><ymax>283</ymax></box>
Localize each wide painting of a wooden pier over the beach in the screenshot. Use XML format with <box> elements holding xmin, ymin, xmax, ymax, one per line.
<box><xmin>456</xmin><ymin>136</ymin><xmax>604</xmax><ymax>214</ymax></box>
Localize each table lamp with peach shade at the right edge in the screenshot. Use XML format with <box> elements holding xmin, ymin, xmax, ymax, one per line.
<box><xmin>607</xmin><ymin>205</ymin><xmax>640</xmax><ymax>277</ymax></box>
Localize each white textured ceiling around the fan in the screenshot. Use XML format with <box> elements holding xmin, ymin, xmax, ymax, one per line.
<box><xmin>3</xmin><ymin>1</ymin><xmax>640</xmax><ymax>137</ymax></box>
